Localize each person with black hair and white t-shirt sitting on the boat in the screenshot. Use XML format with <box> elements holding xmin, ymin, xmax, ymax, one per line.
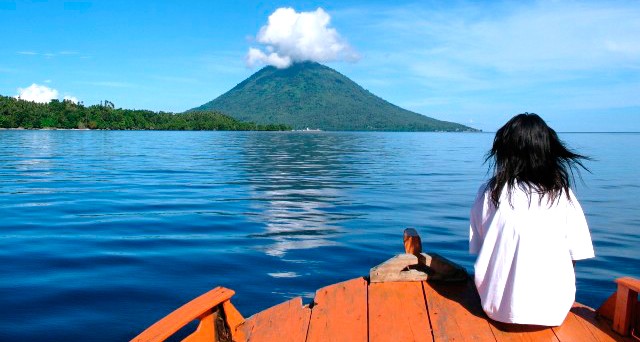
<box><xmin>469</xmin><ymin>113</ymin><xmax>594</xmax><ymax>325</ymax></box>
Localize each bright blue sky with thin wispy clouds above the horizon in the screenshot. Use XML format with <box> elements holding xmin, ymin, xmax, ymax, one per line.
<box><xmin>0</xmin><ymin>0</ymin><xmax>640</xmax><ymax>131</ymax></box>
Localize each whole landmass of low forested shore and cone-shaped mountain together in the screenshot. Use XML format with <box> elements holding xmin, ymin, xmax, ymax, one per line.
<box><xmin>0</xmin><ymin>62</ymin><xmax>478</xmax><ymax>132</ymax></box>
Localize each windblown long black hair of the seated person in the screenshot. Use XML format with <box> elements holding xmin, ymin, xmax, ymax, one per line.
<box><xmin>485</xmin><ymin>113</ymin><xmax>590</xmax><ymax>208</ymax></box>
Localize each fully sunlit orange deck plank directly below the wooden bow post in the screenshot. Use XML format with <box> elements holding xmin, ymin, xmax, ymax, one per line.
<box><xmin>369</xmin><ymin>282</ymin><xmax>433</xmax><ymax>342</ymax></box>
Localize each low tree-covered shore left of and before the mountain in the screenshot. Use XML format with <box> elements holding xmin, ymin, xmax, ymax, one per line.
<box><xmin>0</xmin><ymin>95</ymin><xmax>291</xmax><ymax>131</ymax></box>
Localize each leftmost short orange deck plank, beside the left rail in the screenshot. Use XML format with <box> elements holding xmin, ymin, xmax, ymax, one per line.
<box><xmin>242</xmin><ymin>297</ymin><xmax>311</xmax><ymax>342</ymax></box>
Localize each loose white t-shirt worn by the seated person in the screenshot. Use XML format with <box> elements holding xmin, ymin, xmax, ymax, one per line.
<box><xmin>469</xmin><ymin>184</ymin><xmax>594</xmax><ymax>326</ymax></box>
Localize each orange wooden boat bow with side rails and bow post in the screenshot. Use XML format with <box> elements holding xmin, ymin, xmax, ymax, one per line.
<box><xmin>132</xmin><ymin>229</ymin><xmax>640</xmax><ymax>342</ymax></box>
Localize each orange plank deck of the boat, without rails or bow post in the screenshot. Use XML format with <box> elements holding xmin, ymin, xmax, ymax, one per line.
<box><xmin>240</xmin><ymin>278</ymin><xmax>632</xmax><ymax>342</ymax></box>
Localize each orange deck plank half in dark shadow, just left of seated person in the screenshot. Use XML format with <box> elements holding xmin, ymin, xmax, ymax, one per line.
<box><xmin>423</xmin><ymin>280</ymin><xmax>495</xmax><ymax>342</ymax></box>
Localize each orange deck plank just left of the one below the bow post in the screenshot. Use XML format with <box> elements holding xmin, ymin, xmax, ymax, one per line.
<box><xmin>307</xmin><ymin>278</ymin><xmax>367</xmax><ymax>342</ymax></box>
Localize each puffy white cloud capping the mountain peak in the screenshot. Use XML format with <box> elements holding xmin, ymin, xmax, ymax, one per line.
<box><xmin>246</xmin><ymin>7</ymin><xmax>359</xmax><ymax>68</ymax></box>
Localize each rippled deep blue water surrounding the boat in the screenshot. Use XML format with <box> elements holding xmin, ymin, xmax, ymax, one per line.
<box><xmin>0</xmin><ymin>131</ymin><xmax>640</xmax><ymax>341</ymax></box>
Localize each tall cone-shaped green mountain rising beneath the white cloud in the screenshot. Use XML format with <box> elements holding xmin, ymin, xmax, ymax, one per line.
<box><xmin>189</xmin><ymin>62</ymin><xmax>478</xmax><ymax>132</ymax></box>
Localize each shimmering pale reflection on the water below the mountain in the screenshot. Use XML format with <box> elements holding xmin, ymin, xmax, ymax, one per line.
<box><xmin>242</xmin><ymin>132</ymin><xmax>358</xmax><ymax>260</ymax></box>
